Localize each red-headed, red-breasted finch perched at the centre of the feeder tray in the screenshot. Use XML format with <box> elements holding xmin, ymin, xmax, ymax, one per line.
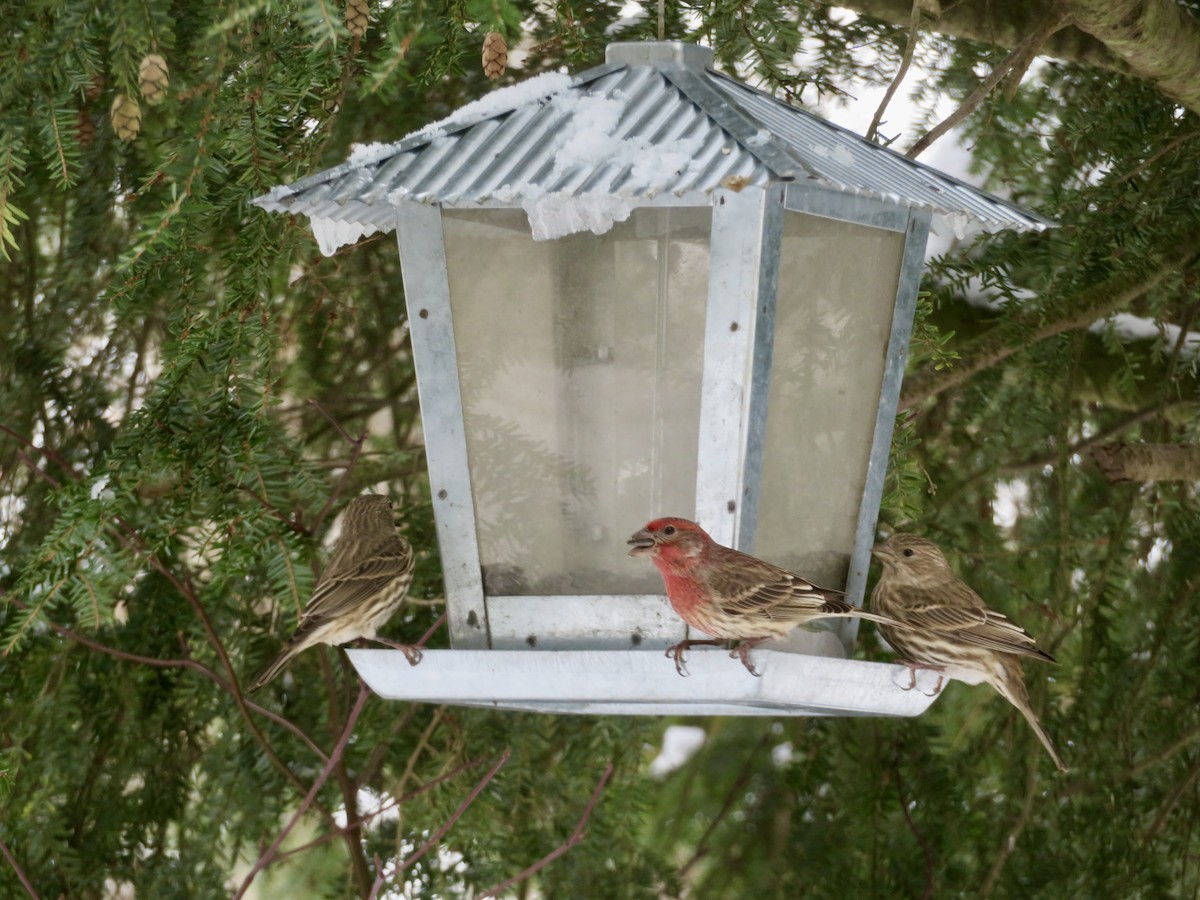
<box><xmin>629</xmin><ymin>518</ymin><xmax>895</xmax><ymax>674</ymax></box>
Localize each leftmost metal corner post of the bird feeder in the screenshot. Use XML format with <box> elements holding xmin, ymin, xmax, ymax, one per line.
<box><xmin>396</xmin><ymin>203</ymin><xmax>491</xmax><ymax>649</ymax></box>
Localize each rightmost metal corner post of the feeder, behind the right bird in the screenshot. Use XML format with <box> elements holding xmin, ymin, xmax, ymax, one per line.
<box><xmin>841</xmin><ymin>209</ymin><xmax>930</xmax><ymax>648</ymax></box>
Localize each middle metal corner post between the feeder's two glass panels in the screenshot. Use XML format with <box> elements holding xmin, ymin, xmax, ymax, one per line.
<box><xmin>696</xmin><ymin>185</ymin><xmax>784</xmax><ymax>551</ymax></box>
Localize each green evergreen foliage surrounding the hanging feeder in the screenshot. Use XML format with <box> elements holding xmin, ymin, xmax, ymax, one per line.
<box><xmin>0</xmin><ymin>0</ymin><xmax>1200</xmax><ymax>898</ymax></box>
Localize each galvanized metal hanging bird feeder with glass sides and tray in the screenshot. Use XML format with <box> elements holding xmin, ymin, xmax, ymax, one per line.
<box><xmin>254</xmin><ymin>42</ymin><xmax>1049</xmax><ymax>715</ymax></box>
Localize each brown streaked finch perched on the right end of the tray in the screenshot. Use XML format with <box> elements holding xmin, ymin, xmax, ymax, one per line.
<box><xmin>871</xmin><ymin>534</ymin><xmax>1067</xmax><ymax>772</ymax></box>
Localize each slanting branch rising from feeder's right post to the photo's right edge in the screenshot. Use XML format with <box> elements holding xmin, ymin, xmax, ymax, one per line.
<box><xmin>900</xmin><ymin>234</ymin><xmax>1200</xmax><ymax>409</ymax></box>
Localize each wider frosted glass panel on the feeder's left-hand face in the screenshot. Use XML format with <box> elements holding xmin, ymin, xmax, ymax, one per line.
<box><xmin>444</xmin><ymin>209</ymin><xmax>712</xmax><ymax>595</ymax></box>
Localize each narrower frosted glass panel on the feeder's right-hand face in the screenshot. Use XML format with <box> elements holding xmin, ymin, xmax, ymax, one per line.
<box><xmin>755</xmin><ymin>212</ymin><xmax>904</xmax><ymax>588</ymax></box>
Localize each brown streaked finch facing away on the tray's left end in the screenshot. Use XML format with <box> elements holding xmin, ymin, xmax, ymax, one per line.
<box><xmin>250</xmin><ymin>494</ymin><xmax>421</xmax><ymax>694</ymax></box>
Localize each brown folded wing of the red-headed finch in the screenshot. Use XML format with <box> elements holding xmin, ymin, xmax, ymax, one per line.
<box><xmin>708</xmin><ymin>553</ymin><xmax>851</xmax><ymax>620</ymax></box>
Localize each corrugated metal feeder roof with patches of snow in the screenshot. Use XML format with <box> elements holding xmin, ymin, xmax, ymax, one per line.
<box><xmin>254</xmin><ymin>43</ymin><xmax>1052</xmax><ymax>240</ymax></box>
